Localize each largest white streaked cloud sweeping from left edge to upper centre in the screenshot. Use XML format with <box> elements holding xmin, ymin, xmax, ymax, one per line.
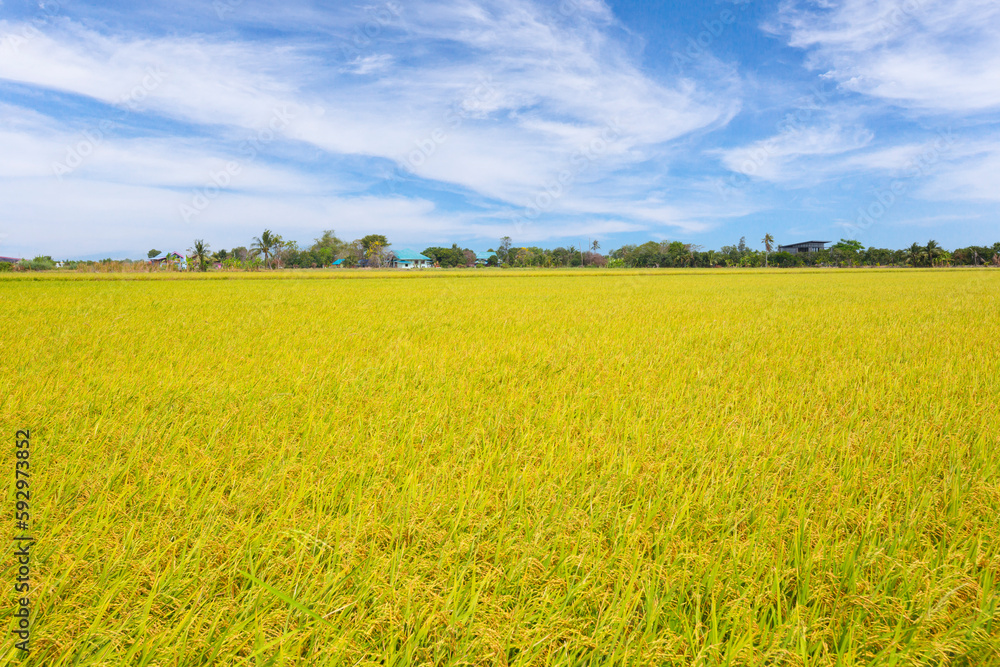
<box><xmin>0</xmin><ymin>0</ymin><xmax>739</xmax><ymax>227</ymax></box>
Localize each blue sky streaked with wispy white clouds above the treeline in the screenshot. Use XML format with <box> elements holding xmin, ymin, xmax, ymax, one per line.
<box><xmin>0</xmin><ymin>0</ymin><xmax>1000</xmax><ymax>258</ymax></box>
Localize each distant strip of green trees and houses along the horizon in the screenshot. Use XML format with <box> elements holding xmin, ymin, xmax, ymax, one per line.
<box><xmin>0</xmin><ymin>229</ymin><xmax>1000</xmax><ymax>272</ymax></box>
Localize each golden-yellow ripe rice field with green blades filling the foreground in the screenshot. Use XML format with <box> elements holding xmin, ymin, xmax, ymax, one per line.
<box><xmin>0</xmin><ymin>270</ymin><xmax>1000</xmax><ymax>666</ymax></box>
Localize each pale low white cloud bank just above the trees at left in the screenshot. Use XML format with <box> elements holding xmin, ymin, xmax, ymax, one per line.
<box><xmin>0</xmin><ymin>174</ymin><xmax>474</xmax><ymax>257</ymax></box>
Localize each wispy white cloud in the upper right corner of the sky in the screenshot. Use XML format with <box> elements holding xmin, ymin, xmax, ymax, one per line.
<box><xmin>769</xmin><ymin>0</ymin><xmax>1000</xmax><ymax>112</ymax></box>
